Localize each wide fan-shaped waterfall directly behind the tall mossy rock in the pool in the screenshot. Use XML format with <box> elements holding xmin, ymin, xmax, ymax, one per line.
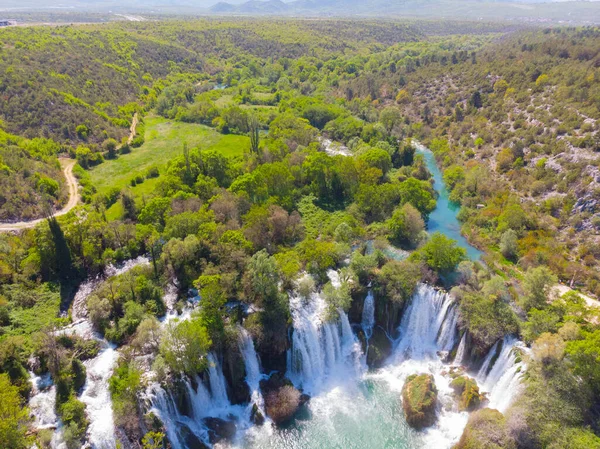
<box><xmin>395</xmin><ymin>284</ymin><xmax>458</xmax><ymax>360</ymax></box>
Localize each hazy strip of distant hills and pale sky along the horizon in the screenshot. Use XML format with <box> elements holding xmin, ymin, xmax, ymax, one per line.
<box><xmin>0</xmin><ymin>0</ymin><xmax>600</xmax><ymax>24</ymax></box>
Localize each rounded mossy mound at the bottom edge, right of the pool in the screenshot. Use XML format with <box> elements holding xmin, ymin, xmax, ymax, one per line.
<box><xmin>452</xmin><ymin>408</ymin><xmax>516</xmax><ymax>449</ymax></box>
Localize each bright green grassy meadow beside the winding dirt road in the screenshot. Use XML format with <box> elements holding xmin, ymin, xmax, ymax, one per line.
<box><xmin>89</xmin><ymin>116</ymin><xmax>250</xmax><ymax>196</ymax></box>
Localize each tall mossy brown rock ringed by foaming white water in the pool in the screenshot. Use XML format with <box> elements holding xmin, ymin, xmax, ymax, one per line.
<box><xmin>402</xmin><ymin>374</ymin><xmax>437</xmax><ymax>429</ymax></box>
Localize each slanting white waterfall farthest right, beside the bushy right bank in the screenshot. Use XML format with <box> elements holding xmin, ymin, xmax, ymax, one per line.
<box><xmin>477</xmin><ymin>336</ymin><xmax>525</xmax><ymax>412</ymax></box>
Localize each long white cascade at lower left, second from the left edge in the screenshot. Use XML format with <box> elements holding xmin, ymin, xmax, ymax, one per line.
<box><xmin>80</xmin><ymin>344</ymin><xmax>119</xmax><ymax>449</ymax></box>
